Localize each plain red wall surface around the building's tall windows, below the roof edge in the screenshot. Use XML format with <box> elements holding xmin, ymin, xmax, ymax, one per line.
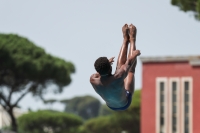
<box><xmin>141</xmin><ymin>62</ymin><xmax>200</xmax><ymax>133</ymax></box>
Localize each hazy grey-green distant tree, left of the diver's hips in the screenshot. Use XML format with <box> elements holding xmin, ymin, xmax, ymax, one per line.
<box><xmin>61</xmin><ymin>96</ymin><xmax>101</xmax><ymax>119</ymax></box>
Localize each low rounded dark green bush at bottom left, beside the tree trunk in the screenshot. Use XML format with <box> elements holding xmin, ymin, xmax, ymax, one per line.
<box><xmin>18</xmin><ymin>111</ymin><xmax>84</xmax><ymax>133</ymax></box>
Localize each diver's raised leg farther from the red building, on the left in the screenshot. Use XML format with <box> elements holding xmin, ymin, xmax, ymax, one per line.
<box><xmin>117</xmin><ymin>24</ymin><xmax>129</xmax><ymax>69</ymax></box>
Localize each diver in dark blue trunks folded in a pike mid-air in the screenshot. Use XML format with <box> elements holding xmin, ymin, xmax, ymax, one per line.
<box><xmin>90</xmin><ymin>24</ymin><xmax>140</xmax><ymax>111</ymax></box>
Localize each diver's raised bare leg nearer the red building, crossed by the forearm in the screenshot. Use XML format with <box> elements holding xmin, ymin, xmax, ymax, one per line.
<box><xmin>124</xmin><ymin>24</ymin><xmax>137</xmax><ymax>94</ymax></box>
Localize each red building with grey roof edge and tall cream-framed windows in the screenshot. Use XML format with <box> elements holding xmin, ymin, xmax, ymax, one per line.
<box><xmin>140</xmin><ymin>56</ymin><xmax>200</xmax><ymax>133</ymax></box>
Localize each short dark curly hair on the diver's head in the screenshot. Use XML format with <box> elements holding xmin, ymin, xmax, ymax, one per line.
<box><xmin>94</xmin><ymin>57</ymin><xmax>110</xmax><ymax>74</ymax></box>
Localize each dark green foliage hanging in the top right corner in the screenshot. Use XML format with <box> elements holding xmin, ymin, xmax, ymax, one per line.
<box><xmin>171</xmin><ymin>0</ymin><xmax>200</xmax><ymax>20</ymax></box>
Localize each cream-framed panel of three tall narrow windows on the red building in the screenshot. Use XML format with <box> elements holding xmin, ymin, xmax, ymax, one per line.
<box><xmin>156</xmin><ymin>77</ymin><xmax>192</xmax><ymax>133</ymax></box>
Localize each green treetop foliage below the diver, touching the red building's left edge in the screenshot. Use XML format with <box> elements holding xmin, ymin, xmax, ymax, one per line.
<box><xmin>84</xmin><ymin>90</ymin><xmax>140</xmax><ymax>133</ymax></box>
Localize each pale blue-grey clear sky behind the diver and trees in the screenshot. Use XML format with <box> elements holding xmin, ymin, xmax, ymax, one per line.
<box><xmin>0</xmin><ymin>0</ymin><xmax>200</xmax><ymax>110</ymax></box>
